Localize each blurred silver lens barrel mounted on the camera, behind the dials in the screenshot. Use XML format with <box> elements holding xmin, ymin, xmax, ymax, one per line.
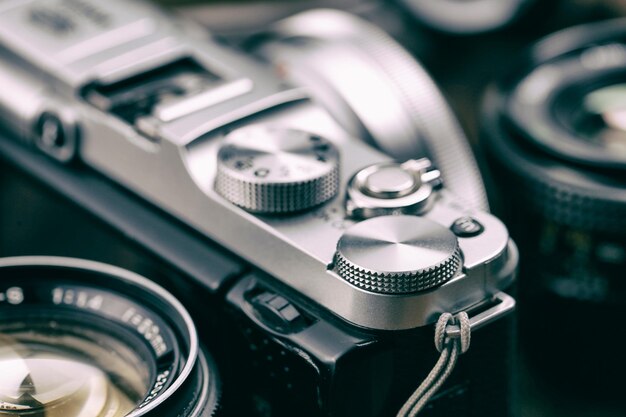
<box><xmin>254</xmin><ymin>8</ymin><xmax>488</xmax><ymax>210</ymax></box>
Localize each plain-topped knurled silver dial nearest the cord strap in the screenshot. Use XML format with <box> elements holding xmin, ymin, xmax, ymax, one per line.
<box><xmin>335</xmin><ymin>216</ymin><xmax>463</xmax><ymax>294</ymax></box>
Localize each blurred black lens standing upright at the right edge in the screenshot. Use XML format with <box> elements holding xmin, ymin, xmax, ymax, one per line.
<box><xmin>483</xmin><ymin>20</ymin><xmax>626</xmax><ymax>389</ymax></box>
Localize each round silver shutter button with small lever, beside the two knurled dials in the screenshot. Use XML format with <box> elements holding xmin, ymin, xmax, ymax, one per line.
<box><xmin>346</xmin><ymin>158</ymin><xmax>441</xmax><ymax>219</ymax></box>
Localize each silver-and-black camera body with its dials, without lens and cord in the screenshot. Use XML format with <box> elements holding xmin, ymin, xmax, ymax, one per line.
<box><xmin>0</xmin><ymin>0</ymin><xmax>517</xmax><ymax>416</ymax></box>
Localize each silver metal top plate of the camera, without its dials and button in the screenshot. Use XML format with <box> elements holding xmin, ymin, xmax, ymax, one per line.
<box><xmin>0</xmin><ymin>0</ymin><xmax>517</xmax><ymax>330</ymax></box>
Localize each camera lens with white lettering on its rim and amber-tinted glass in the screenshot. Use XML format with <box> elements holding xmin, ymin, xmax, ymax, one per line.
<box><xmin>0</xmin><ymin>257</ymin><xmax>219</xmax><ymax>417</ymax></box>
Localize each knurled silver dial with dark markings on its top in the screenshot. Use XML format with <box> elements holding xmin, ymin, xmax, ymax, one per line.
<box><xmin>215</xmin><ymin>125</ymin><xmax>339</xmax><ymax>214</ymax></box>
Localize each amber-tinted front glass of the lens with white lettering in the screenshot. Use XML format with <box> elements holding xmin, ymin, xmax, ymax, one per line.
<box><xmin>0</xmin><ymin>320</ymin><xmax>151</xmax><ymax>417</ymax></box>
